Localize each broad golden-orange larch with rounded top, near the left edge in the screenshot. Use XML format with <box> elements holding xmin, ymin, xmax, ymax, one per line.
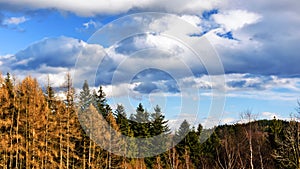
<box><xmin>18</xmin><ymin>77</ymin><xmax>49</xmax><ymax>168</ymax></box>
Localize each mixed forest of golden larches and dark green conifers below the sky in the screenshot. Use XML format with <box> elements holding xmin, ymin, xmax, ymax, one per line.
<box><xmin>0</xmin><ymin>73</ymin><xmax>300</xmax><ymax>169</ymax></box>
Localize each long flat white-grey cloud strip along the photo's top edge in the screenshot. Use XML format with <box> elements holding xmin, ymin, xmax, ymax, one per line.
<box><xmin>0</xmin><ymin>0</ymin><xmax>225</xmax><ymax>16</ymax></box>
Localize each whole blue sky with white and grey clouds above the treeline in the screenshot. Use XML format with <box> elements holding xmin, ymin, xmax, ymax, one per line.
<box><xmin>0</xmin><ymin>0</ymin><xmax>300</xmax><ymax>127</ymax></box>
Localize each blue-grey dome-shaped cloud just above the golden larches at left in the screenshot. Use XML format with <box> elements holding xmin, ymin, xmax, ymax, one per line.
<box><xmin>10</xmin><ymin>37</ymin><xmax>84</xmax><ymax>70</ymax></box>
